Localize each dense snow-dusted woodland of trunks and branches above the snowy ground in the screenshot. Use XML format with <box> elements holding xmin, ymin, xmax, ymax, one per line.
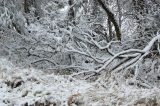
<box><xmin>0</xmin><ymin>0</ymin><xmax>160</xmax><ymax>106</ymax></box>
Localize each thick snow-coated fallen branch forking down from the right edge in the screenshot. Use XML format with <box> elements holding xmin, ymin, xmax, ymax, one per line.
<box><xmin>72</xmin><ymin>34</ymin><xmax>160</xmax><ymax>79</ymax></box>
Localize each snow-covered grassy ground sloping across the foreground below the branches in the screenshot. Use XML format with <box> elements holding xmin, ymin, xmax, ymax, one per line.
<box><xmin>0</xmin><ymin>59</ymin><xmax>160</xmax><ymax>106</ymax></box>
